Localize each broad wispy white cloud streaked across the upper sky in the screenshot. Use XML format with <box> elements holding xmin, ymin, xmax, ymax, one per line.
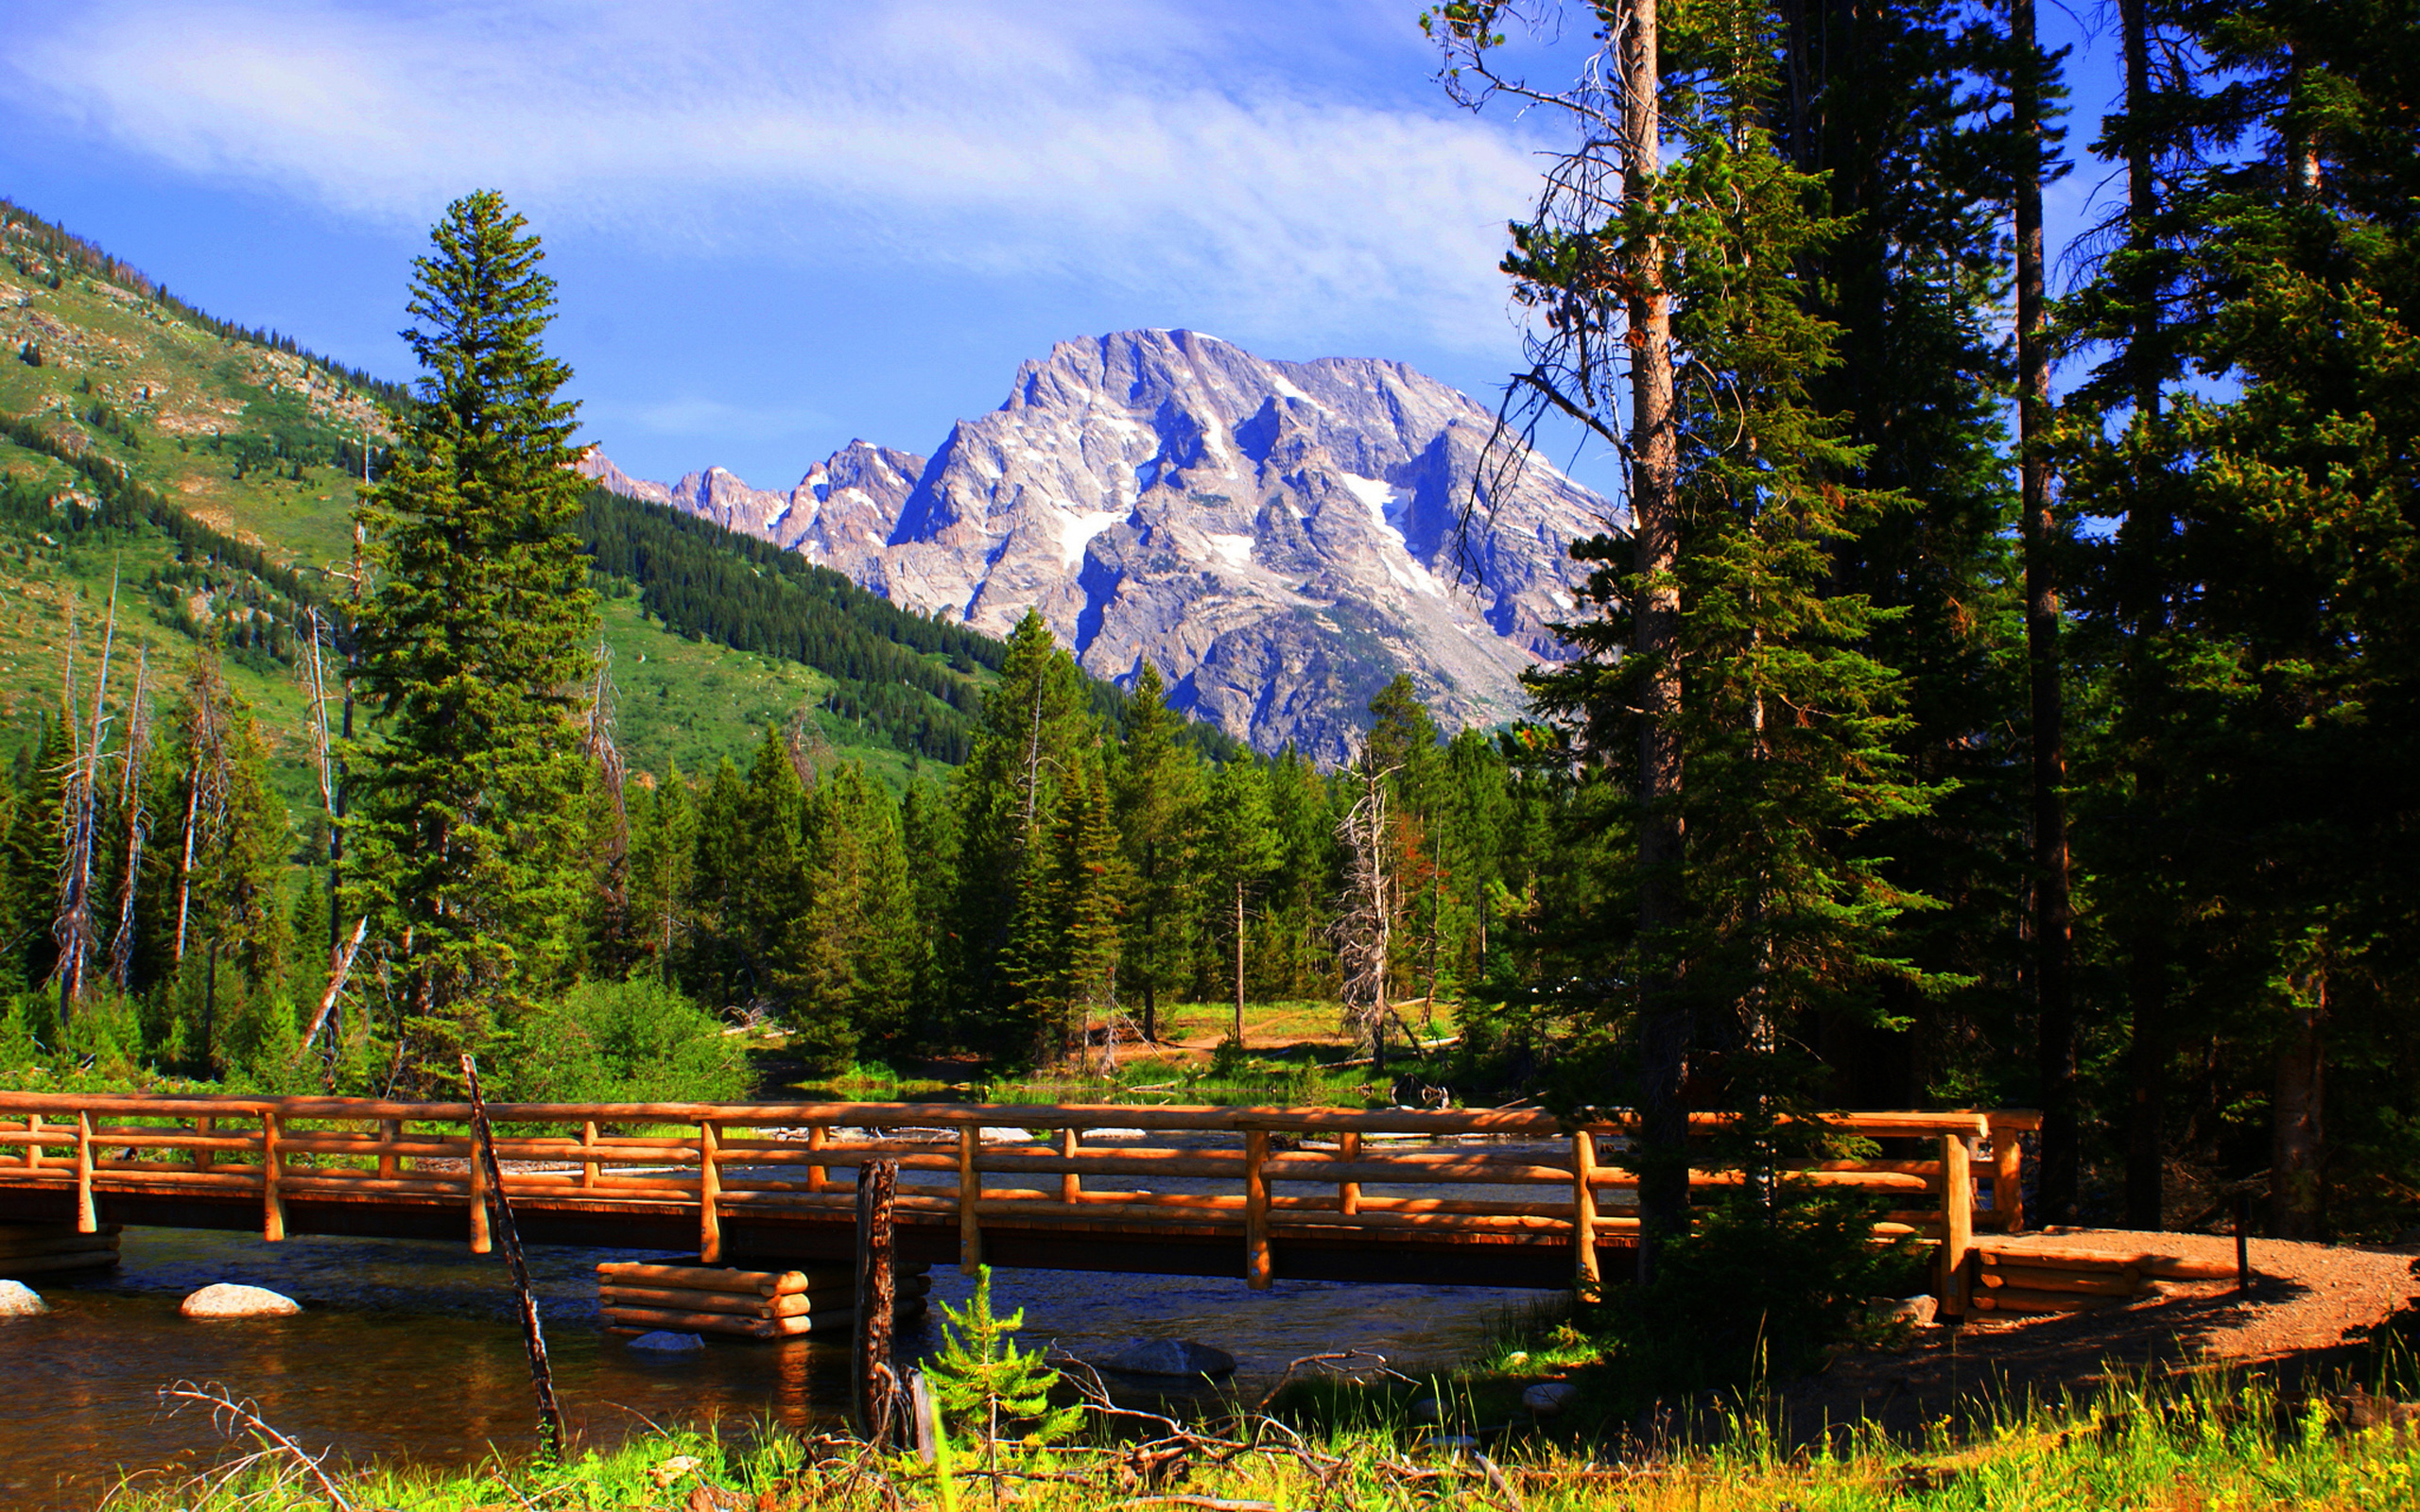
<box><xmin>0</xmin><ymin>0</ymin><xmax>1537</xmax><ymax>351</ymax></box>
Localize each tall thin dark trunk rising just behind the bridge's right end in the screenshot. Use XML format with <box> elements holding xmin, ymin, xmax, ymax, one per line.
<box><xmin>2009</xmin><ymin>0</ymin><xmax>2076</xmax><ymax>1224</ymax></box>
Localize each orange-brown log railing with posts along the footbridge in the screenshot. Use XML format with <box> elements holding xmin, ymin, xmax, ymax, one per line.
<box><xmin>0</xmin><ymin>1093</ymin><xmax>2040</xmax><ymax>1306</ymax></box>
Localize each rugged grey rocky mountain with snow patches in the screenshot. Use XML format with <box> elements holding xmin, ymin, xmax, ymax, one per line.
<box><xmin>586</xmin><ymin>332</ymin><xmax>1615</xmax><ymax>760</ymax></box>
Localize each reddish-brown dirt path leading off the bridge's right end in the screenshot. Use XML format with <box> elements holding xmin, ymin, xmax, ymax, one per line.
<box><xmin>1784</xmin><ymin>1228</ymin><xmax>2420</xmax><ymax>1433</ymax></box>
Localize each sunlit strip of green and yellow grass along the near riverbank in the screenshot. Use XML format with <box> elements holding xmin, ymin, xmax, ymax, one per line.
<box><xmin>107</xmin><ymin>1377</ymin><xmax>2420</xmax><ymax>1512</ymax></box>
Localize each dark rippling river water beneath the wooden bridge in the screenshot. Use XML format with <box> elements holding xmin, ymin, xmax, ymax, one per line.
<box><xmin>0</xmin><ymin>1228</ymin><xmax>1534</xmax><ymax>1509</ymax></box>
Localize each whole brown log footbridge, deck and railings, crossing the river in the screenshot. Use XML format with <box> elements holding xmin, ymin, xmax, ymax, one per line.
<box><xmin>0</xmin><ymin>1093</ymin><xmax>2040</xmax><ymax>1304</ymax></box>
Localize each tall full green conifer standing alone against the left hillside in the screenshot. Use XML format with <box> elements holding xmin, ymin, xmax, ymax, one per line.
<box><xmin>346</xmin><ymin>191</ymin><xmax>596</xmax><ymax>1089</ymax></box>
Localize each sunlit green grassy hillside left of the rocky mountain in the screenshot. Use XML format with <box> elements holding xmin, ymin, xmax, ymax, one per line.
<box><xmin>0</xmin><ymin>203</ymin><xmax>962</xmax><ymax>805</ymax></box>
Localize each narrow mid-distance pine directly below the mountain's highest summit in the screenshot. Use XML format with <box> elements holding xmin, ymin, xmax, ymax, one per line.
<box><xmin>1111</xmin><ymin>662</ymin><xmax>1202</xmax><ymax>1042</ymax></box>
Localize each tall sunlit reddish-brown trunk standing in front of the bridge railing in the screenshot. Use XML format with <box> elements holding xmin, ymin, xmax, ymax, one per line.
<box><xmin>1619</xmin><ymin>0</ymin><xmax>1689</xmax><ymax>1280</ymax></box>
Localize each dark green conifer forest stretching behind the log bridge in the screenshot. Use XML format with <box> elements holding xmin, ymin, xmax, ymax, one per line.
<box><xmin>0</xmin><ymin>0</ymin><xmax>2420</xmax><ymax>1251</ymax></box>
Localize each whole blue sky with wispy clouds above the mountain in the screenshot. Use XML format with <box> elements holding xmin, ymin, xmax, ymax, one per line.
<box><xmin>0</xmin><ymin>0</ymin><xmax>2113</xmax><ymax>498</ymax></box>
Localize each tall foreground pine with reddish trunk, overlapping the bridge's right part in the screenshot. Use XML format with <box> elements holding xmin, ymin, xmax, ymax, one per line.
<box><xmin>1432</xmin><ymin>5</ymin><xmax>1931</xmax><ymax>1278</ymax></box>
